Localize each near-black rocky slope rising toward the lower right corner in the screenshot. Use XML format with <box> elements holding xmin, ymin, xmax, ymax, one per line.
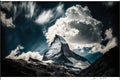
<box><xmin>79</xmin><ymin>47</ymin><xmax>119</xmax><ymax>77</ymax></box>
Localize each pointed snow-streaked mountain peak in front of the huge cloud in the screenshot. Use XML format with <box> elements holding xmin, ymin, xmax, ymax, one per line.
<box><xmin>43</xmin><ymin>35</ymin><xmax>90</xmax><ymax>69</ymax></box>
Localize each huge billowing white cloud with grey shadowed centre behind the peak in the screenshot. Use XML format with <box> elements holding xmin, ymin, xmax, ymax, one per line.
<box><xmin>46</xmin><ymin>5</ymin><xmax>102</xmax><ymax>49</ymax></box>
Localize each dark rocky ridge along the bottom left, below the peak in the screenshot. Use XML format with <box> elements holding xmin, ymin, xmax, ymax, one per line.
<box><xmin>1</xmin><ymin>59</ymin><xmax>79</xmax><ymax>77</ymax></box>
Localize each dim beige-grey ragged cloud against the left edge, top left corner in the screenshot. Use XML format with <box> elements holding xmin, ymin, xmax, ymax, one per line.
<box><xmin>0</xmin><ymin>2</ymin><xmax>15</xmax><ymax>28</ymax></box>
